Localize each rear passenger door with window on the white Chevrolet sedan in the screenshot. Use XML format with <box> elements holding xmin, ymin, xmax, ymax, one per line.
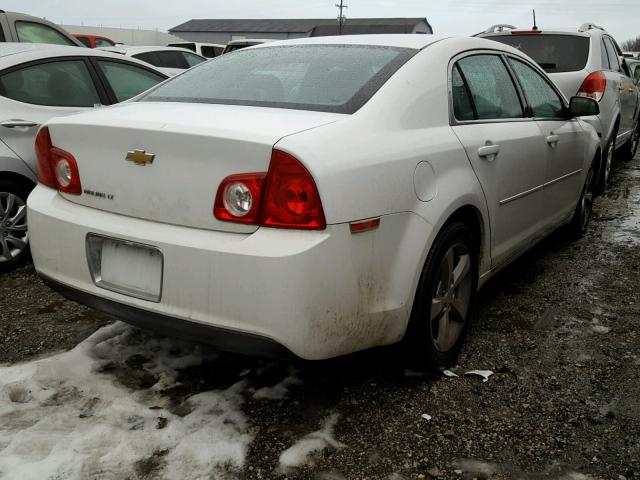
<box><xmin>451</xmin><ymin>54</ymin><xmax>546</xmax><ymax>266</ymax></box>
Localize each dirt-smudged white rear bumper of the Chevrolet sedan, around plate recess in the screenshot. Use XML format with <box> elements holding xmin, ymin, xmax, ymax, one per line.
<box><xmin>28</xmin><ymin>186</ymin><xmax>431</xmax><ymax>360</ymax></box>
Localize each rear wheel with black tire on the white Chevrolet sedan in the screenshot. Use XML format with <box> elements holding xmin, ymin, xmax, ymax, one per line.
<box><xmin>404</xmin><ymin>221</ymin><xmax>478</xmax><ymax>371</ymax></box>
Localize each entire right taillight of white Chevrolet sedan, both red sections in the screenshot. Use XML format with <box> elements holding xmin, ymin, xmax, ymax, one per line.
<box><xmin>213</xmin><ymin>150</ymin><xmax>326</xmax><ymax>230</ymax></box>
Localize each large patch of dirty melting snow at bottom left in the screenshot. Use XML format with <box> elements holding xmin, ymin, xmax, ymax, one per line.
<box><xmin>0</xmin><ymin>323</ymin><xmax>253</xmax><ymax>480</ymax></box>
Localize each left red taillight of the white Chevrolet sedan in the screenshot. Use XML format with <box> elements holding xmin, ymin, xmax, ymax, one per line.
<box><xmin>36</xmin><ymin>127</ymin><xmax>82</xmax><ymax>195</ymax></box>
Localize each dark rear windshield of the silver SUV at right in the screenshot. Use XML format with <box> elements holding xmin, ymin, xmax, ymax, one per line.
<box><xmin>487</xmin><ymin>34</ymin><xmax>589</xmax><ymax>73</ymax></box>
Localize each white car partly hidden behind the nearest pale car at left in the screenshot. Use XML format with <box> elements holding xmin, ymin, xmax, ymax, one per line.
<box><xmin>102</xmin><ymin>45</ymin><xmax>207</xmax><ymax>76</ymax></box>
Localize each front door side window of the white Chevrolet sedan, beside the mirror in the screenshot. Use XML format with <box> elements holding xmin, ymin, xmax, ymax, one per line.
<box><xmin>509</xmin><ymin>58</ymin><xmax>564</xmax><ymax>118</ymax></box>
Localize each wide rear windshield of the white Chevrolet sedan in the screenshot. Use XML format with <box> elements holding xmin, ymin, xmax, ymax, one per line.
<box><xmin>142</xmin><ymin>45</ymin><xmax>417</xmax><ymax>113</ymax></box>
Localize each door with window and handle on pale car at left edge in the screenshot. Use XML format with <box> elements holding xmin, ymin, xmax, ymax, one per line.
<box><xmin>0</xmin><ymin>59</ymin><xmax>101</xmax><ymax>168</ymax></box>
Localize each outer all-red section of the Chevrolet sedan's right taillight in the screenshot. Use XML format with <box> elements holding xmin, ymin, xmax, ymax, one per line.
<box><xmin>260</xmin><ymin>150</ymin><xmax>327</xmax><ymax>230</ymax></box>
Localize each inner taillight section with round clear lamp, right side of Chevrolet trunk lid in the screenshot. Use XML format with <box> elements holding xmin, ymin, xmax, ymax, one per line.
<box><xmin>213</xmin><ymin>173</ymin><xmax>267</xmax><ymax>225</ymax></box>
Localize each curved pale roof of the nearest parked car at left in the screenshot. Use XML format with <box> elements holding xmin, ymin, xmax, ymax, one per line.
<box><xmin>0</xmin><ymin>43</ymin><xmax>166</xmax><ymax>77</ymax></box>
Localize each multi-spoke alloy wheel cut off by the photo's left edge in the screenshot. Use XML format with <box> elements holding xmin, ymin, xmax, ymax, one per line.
<box><xmin>0</xmin><ymin>192</ymin><xmax>29</xmax><ymax>263</ymax></box>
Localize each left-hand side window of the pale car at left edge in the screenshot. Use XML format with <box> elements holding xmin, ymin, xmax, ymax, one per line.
<box><xmin>0</xmin><ymin>60</ymin><xmax>101</xmax><ymax>107</ymax></box>
